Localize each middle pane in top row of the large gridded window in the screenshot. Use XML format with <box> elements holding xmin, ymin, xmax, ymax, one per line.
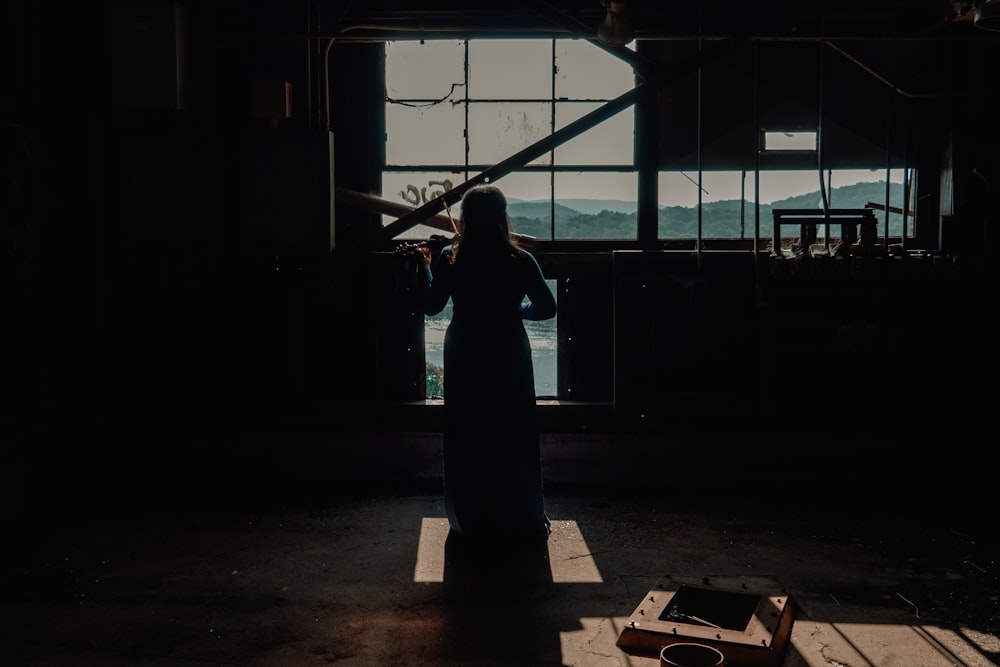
<box><xmin>469</xmin><ymin>39</ymin><xmax>552</xmax><ymax>100</ymax></box>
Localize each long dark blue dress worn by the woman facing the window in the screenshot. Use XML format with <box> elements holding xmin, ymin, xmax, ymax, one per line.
<box><xmin>416</xmin><ymin>247</ymin><xmax>556</xmax><ymax>540</ymax></box>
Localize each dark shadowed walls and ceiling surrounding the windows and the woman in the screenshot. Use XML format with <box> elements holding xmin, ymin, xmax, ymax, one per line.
<box><xmin>0</xmin><ymin>0</ymin><xmax>1000</xmax><ymax>528</ymax></box>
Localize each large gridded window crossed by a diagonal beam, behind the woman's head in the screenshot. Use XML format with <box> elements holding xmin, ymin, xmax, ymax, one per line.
<box><xmin>382</xmin><ymin>39</ymin><xmax>638</xmax><ymax>240</ymax></box>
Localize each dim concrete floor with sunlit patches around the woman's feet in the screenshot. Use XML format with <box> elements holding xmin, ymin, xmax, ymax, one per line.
<box><xmin>0</xmin><ymin>485</ymin><xmax>1000</xmax><ymax>667</ymax></box>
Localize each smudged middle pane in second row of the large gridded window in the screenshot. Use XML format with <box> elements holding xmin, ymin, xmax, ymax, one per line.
<box><xmin>469</xmin><ymin>102</ymin><xmax>552</xmax><ymax>165</ymax></box>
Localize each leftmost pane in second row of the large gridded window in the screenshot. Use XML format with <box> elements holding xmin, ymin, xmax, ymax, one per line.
<box><xmin>385</xmin><ymin>102</ymin><xmax>465</xmax><ymax>165</ymax></box>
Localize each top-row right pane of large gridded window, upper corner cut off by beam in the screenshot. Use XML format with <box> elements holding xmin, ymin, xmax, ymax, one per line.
<box><xmin>555</xmin><ymin>39</ymin><xmax>635</xmax><ymax>100</ymax></box>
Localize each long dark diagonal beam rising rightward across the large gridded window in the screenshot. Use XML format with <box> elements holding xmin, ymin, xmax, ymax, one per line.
<box><xmin>380</xmin><ymin>40</ymin><xmax>722</xmax><ymax>240</ymax></box>
